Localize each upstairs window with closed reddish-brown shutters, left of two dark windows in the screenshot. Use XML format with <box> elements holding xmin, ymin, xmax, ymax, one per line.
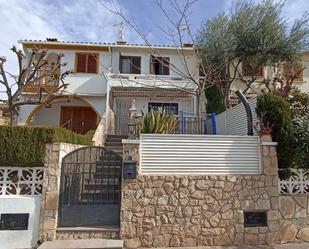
<box><xmin>76</xmin><ymin>53</ymin><xmax>99</xmax><ymax>73</ymax></box>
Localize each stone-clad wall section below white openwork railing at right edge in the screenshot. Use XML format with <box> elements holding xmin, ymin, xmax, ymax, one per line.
<box><xmin>279</xmin><ymin>194</ymin><xmax>309</xmax><ymax>243</ymax></box>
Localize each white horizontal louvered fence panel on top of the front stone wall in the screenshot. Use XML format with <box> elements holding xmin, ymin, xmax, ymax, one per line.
<box><xmin>140</xmin><ymin>134</ymin><xmax>260</xmax><ymax>175</ymax></box>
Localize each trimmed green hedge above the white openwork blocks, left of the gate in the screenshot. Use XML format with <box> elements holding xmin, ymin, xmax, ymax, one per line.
<box><xmin>0</xmin><ymin>126</ymin><xmax>93</xmax><ymax>167</ymax></box>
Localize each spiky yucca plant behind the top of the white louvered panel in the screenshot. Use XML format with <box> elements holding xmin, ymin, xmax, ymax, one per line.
<box><xmin>137</xmin><ymin>111</ymin><xmax>179</xmax><ymax>136</ymax></box>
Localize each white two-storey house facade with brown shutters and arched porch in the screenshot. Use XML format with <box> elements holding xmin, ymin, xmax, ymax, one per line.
<box><xmin>17</xmin><ymin>39</ymin><xmax>199</xmax><ymax>139</ymax></box>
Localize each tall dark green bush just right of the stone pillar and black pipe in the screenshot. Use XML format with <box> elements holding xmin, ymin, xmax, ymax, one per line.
<box><xmin>256</xmin><ymin>94</ymin><xmax>295</xmax><ymax>168</ymax></box>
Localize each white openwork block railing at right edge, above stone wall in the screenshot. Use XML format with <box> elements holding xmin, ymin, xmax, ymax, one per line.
<box><xmin>278</xmin><ymin>169</ymin><xmax>309</xmax><ymax>194</ymax></box>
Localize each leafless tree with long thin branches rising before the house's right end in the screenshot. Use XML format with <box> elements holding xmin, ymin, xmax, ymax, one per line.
<box><xmin>98</xmin><ymin>0</ymin><xmax>218</xmax><ymax>131</ymax></box>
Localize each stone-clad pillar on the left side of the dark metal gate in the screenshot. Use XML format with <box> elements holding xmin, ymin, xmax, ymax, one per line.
<box><xmin>39</xmin><ymin>143</ymin><xmax>84</xmax><ymax>241</ymax></box>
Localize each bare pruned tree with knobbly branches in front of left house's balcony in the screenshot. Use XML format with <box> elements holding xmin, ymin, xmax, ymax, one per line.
<box><xmin>0</xmin><ymin>46</ymin><xmax>70</xmax><ymax>124</ymax></box>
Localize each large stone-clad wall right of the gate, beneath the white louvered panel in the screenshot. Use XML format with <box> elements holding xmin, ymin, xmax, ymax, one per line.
<box><xmin>121</xmin><ymin>140</ymin><xmax>280</xmax><ymax>248</ymax></box>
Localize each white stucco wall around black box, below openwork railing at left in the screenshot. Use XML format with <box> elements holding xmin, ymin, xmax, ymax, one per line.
<box><xmin>0</xmin><ymin>195</ymin><xmax>41</xmax><ymax>249</ymax></box>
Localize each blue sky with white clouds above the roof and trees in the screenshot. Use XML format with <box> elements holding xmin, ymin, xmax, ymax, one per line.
<box><xmin>0</xmin><ymin>0</ymin><xmax>309</xmax><ymax>97</ymax></box>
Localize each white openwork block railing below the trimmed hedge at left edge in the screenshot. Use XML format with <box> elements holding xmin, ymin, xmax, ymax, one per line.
<box><xmin>0</xmin><ymin>167</ymin><xmax>43</xmax><ymax>196</ymax></box>
